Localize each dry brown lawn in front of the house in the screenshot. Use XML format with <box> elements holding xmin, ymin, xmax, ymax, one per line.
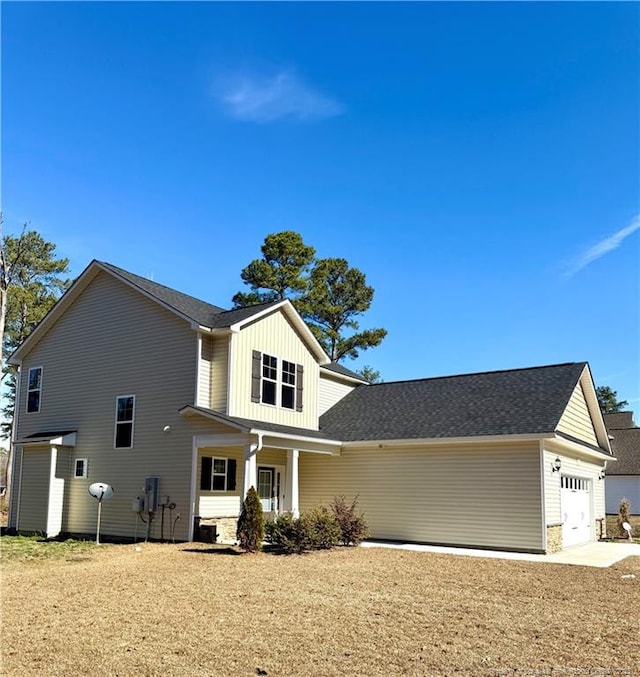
<box><xmin>0</xmin><ymin>544</ymin><xmax>640</xmax><ymax>677</ymax></box>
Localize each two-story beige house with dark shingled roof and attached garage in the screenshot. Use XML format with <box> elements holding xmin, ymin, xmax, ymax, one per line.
<box><xmin>9</xmin><ymin>261</ymin><xmax>612</xmax><ymax>552</ymax></box>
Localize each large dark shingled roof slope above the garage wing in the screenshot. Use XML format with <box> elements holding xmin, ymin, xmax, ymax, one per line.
<box><xmin>320</xmin><ymin>362</ymin><xmax>586</xmax><ymax>441</ymax></box>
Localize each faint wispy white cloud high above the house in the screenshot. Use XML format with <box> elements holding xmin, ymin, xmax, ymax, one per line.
<box><xmin>219</xmin><ymin>72</ymin><xmax>344</xmax><ymax>122</ymax></box>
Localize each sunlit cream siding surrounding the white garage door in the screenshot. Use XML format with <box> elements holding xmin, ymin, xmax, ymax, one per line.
<box><xmin>543</xmin><ymin>448</ymin><xmax>605</xmax><ymax>525</ymax></box>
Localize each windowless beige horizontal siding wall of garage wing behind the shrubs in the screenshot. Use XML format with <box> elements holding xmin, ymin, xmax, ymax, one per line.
<box><xmin>300</xmin><ymin>445</ymin><xmax>543</xmax><ymax>551</ymax></box>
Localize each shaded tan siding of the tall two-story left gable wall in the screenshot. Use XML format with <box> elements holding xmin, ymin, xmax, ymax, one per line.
<box><xmin>18</xmin><ymin>272</ymin><xmax>202</xmax><ymax>539</ymax></box>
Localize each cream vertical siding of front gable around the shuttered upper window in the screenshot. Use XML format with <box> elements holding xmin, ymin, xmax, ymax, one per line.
<box><xmin>229</xmin><ymin>310</ymin><xmax>320</xmax><ymax>430</ymax></box>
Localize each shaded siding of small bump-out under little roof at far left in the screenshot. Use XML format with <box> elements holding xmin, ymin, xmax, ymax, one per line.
<box><xmin>18</xmin><ymin>447</ymin><xmax>51</xmax><ymax>533</ymax></box>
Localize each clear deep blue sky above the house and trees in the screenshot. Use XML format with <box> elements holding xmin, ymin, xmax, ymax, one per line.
<box><xmin>1</xmin><ymin>2</ymin><xmax>640</xmax><ymax>406</ymax></box>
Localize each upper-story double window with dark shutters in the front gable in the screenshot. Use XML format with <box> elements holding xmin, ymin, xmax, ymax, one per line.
<box><xmin>251</xmin><ymin>350</ymin><xmax>304</xmax><ymax>411</ymax></box>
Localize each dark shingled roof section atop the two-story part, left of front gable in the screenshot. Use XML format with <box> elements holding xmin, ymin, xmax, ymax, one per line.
<box><xmin>98</xmin><ymin>261</ymin><xmax>275</xmax><ymax>329</ymax></box>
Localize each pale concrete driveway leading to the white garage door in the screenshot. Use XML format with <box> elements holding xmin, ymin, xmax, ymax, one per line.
<box><xmin>361</xmin><ymin>541</ymin><xmax>640</xmax><ymax>568</ymax></box>
